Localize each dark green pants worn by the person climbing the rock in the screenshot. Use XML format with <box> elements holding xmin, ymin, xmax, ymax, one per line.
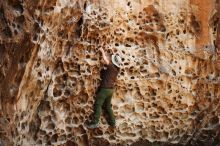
<box><xmin>93</xmin><ymin>88</ymin><xmax>115</xmax><ymax>126</ymax></box>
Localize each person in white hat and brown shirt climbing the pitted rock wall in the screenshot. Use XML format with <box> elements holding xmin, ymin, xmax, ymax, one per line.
<box><xmin>87</xmin><ymin>48</ymin><xmax>121</xmax><ymax>129</ymax></box>
